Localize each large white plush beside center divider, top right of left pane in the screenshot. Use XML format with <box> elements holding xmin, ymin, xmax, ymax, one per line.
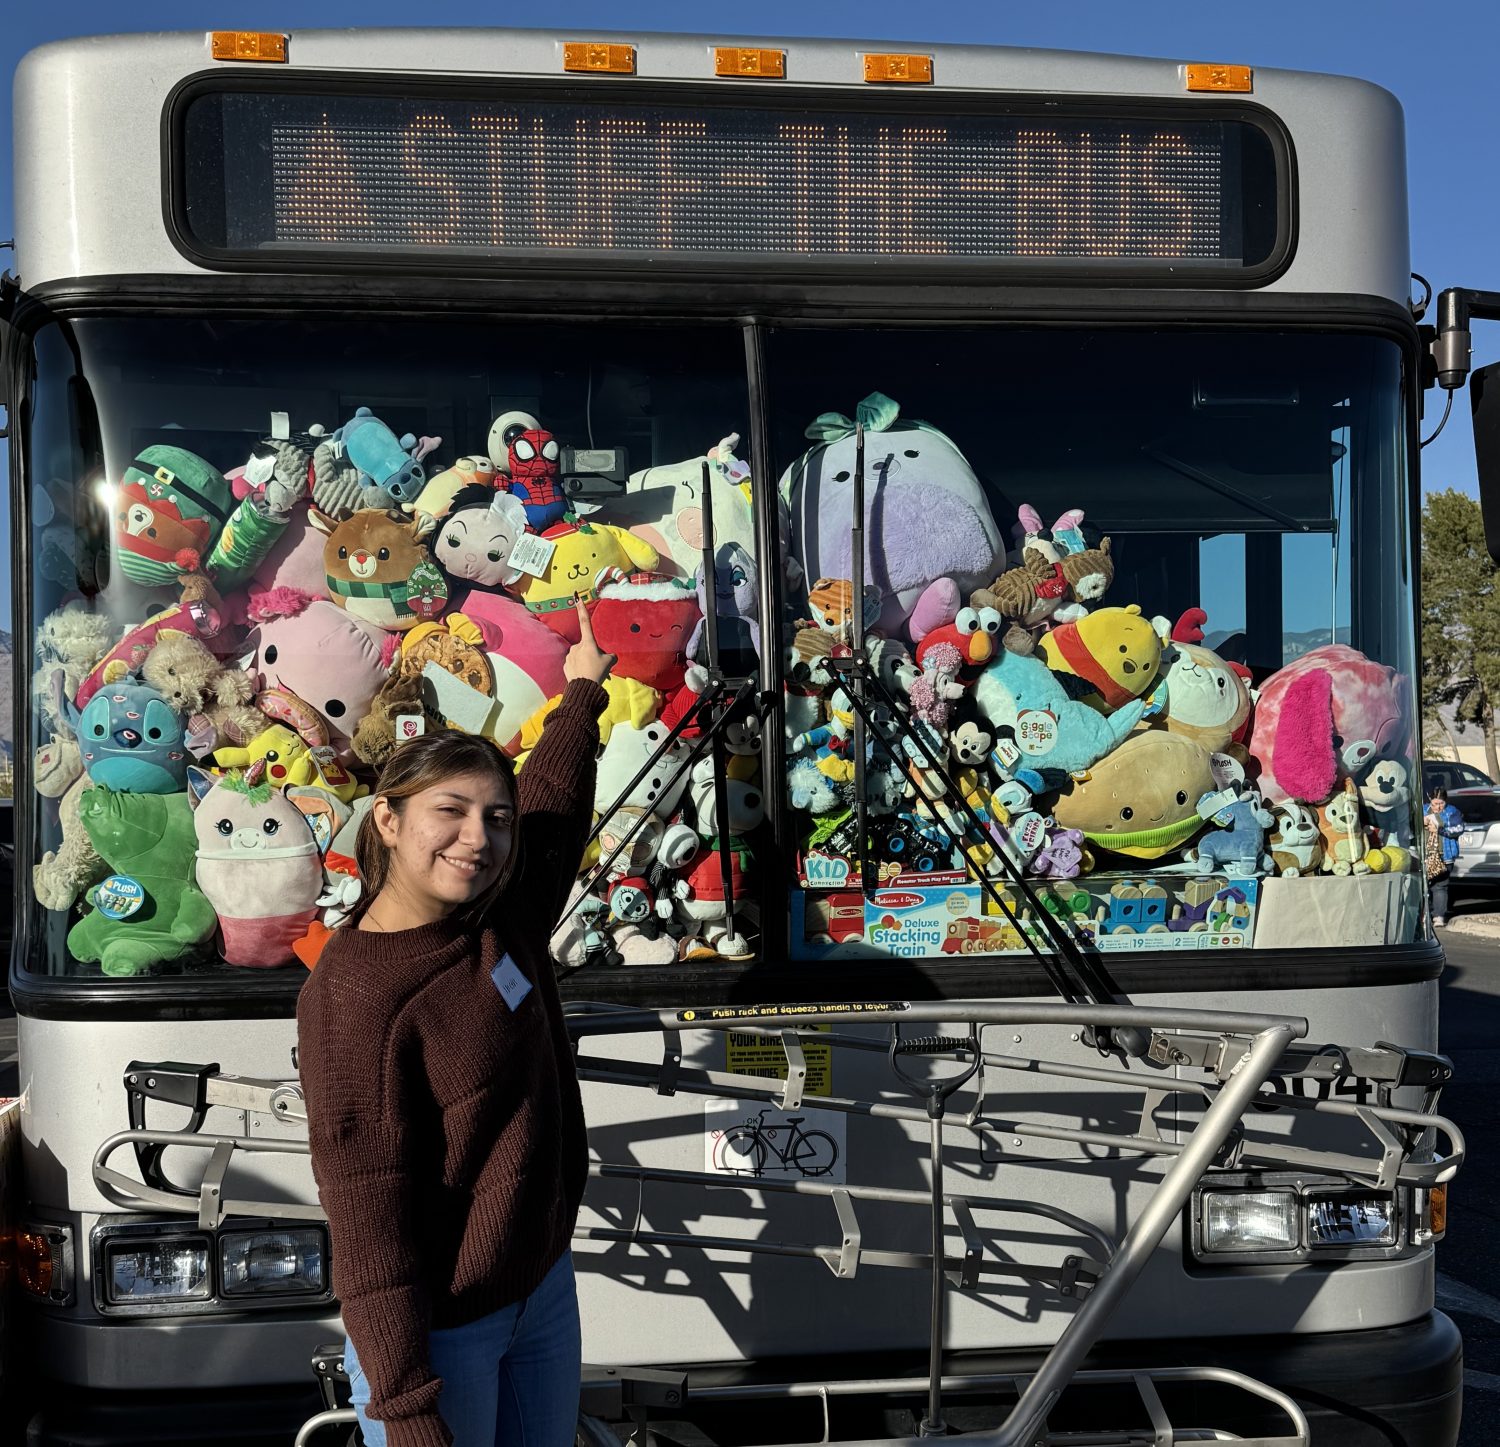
<box><xmin>609</xmin><ymin>433</ymin><xmax>756</xmax><ymax>577</ymax></box>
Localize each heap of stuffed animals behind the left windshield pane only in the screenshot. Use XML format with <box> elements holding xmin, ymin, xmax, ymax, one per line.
<box><xmin>33</xmin><ymin>408</ymin><xmax>764</xmax><ymax>976</ymax></box>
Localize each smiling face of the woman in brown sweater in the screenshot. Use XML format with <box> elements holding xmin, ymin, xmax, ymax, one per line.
<box><xmin>372</xmin><ymin>774</ymin><xmax>516</xmax><ymax>918</ymax></box>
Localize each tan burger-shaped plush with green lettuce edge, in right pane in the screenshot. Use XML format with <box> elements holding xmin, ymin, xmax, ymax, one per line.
<box><xmin>1053</xmin><ymin>734</ymin><xmax>1215</xmax><ymax>859</ymax></box>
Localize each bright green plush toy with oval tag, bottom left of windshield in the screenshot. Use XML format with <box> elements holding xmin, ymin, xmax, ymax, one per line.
<box><xmin>68</xmin><ymin>784</ymin><xmax>219</xmax><ymax>976</ymax></box>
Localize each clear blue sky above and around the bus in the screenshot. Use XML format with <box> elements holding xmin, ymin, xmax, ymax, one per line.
<box><xmin>0</xmin><ymin>0</ymin><xmax>1500</xmax><ymax>627</ymax></box>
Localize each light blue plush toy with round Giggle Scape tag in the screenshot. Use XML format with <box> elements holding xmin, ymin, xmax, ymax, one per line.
<box><xmin>974</xmin><ymin>651</ymin><xmax>1140</xmax><ymax>779</ymax></box>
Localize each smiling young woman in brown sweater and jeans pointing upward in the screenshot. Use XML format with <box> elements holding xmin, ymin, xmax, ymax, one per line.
<box><xmin>297</xmin><ymin>604</ymin><xmax>614</xmax><ymax>1447</ymax></box>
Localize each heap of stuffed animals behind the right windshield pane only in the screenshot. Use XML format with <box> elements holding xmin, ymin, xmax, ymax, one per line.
<box><xmin>782</xmin><ymin>394</ymin><xmax>1413</xmax><ymax>917</ymax></box>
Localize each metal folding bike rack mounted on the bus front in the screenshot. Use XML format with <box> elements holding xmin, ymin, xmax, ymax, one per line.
<box><xmin>93</xmin><ymin>1002</ymin><xmax>1466</xmax><ymax>1447</ymax></box>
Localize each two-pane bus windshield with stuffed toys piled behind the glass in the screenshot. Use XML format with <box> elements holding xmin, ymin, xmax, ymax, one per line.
<box><xmin>24</xmin><ymin>315</ymin><xmax>1422</xmax><ymax>994</ymax></box>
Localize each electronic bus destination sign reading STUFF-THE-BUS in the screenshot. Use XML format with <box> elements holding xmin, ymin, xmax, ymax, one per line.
<box><xmin>179</xmin><ymin>90</ymin><xmax>1278</xmax><ymax>273</ymax></box>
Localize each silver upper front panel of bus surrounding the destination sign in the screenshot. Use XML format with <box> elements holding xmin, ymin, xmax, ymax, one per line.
<box><xmin>14</xmin><ymin>28</ymin><xmax>1410</xmax><ymax>303</ymax></box>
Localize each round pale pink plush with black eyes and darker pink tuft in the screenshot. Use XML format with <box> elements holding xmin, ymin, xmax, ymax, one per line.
<box><xmin>249</xmin><ymin>589</ymin><xmax>393</xmax><ymax>762</ymax></box>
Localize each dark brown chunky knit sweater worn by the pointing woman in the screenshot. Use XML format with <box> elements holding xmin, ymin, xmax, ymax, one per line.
<box><xmin>297</xmin><ymin>679</ymin><xmax>606</xmax><ymax>1447</ymax></box>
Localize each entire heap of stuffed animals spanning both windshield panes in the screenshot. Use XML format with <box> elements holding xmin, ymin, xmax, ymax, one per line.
<box><xmin>33</xmin><ymin>393</ymin><xmax>1412</xmax><ymax>976</ymax></box>
